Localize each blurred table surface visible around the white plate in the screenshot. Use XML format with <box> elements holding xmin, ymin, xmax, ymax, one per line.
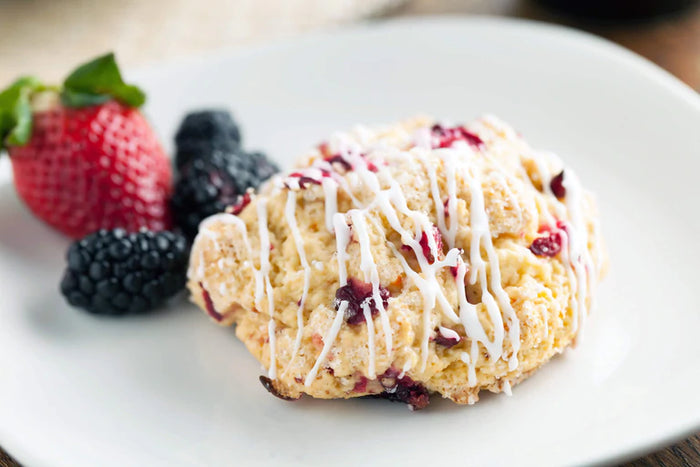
<box><xmin>0</xmin><ymin>0</ymin><xmax>700</xmax><ymax>467</ymax></box>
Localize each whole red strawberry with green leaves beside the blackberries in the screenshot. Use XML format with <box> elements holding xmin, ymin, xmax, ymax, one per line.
<box><xmin>0</xmin><ymin>54</ymin><xmax>172</xmax><ymax>238</ymax></box>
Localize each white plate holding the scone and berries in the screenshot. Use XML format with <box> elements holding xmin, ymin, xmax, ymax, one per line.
<box><xmin>0</xmin><ymin>18</ymin><xmax>700</xmax><ymax>466</ymax></box>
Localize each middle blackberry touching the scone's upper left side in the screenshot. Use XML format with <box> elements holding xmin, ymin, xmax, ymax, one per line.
<box><xmin>170</xmin><ymin>151</ymin><xmax>279</xmax><ymax>241</ymax></box>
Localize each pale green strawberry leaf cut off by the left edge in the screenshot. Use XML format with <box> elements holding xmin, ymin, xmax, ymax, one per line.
<box><xmin>0</xmin><ymin>76</ymin><xmax>41</xmax><ymax>149</ymax></box>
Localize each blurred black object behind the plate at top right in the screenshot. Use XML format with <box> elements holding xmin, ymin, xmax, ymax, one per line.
<box><xmin>536</xmin><ymin>0</ymin><xmax>697</xmax><ymax>20</ymax></box>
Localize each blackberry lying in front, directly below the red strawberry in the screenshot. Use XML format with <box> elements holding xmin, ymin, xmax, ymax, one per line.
<box><xmin>61</xmin><ymin>229</ymin><xmax>188</xmax><ymax>315</ymax></box>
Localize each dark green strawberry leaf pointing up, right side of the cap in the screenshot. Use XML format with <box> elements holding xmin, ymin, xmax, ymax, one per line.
<box><xmin>61</xmin><ymin>53</ymin><xmax>146</xmax><ymax>107</ymax></box>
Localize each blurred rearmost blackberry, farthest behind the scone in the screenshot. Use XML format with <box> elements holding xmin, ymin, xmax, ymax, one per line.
<box><xmin>175</xmin><ymin>110</ymin><xmax>241</xmax><ymax>169</ymax></box>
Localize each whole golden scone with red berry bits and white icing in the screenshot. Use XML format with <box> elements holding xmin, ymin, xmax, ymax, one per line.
<box><xmin>189</xmin><ymin>117</ymin><xmax>605</xmax><ymax>408</ymax></box>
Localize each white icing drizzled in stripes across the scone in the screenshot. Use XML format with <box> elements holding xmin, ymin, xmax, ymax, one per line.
<box><xmin>194</xmin><ymin>117</ymin><xmax>602</xmax><ymax>394</ymax></box>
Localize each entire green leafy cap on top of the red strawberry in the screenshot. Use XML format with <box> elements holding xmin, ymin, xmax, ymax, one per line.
<box><xmin>0</xmin><ymin>53</ymin><xmax>146</xmax><ymax>150</ymax></box>
